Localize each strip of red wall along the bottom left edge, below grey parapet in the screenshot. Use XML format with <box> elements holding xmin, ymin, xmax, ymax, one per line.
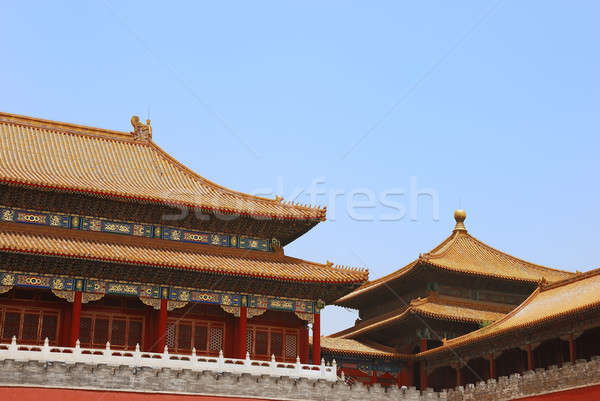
<box><xmin>0</xmin><ymin>387</ymin><xmax>270</xmax><ymax>401</ymax></box>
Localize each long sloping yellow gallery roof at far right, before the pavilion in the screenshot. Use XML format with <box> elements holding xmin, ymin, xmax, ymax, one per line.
<box><xmin>420</xmin><ymin>269</ymin><xmax>600</xmax><ymax>356</ymax></box>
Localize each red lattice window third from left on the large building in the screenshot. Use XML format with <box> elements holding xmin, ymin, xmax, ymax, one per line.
<box><xmin>167</xmin><ymin>319</ymin><xmax>225</xmax><ymax>355</ymax></box>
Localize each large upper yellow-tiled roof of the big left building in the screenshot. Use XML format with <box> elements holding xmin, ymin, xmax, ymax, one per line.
<box><xmin>0</xmin><ymin>113</ymin><xmax>326</xmax><ymax>220</ymax></box>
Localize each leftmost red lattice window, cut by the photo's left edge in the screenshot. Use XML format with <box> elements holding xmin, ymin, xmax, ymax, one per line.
<box><xmin>0</xmin><ymin>307</ymin><xmax>60</xmax><ymax>344</ymax></box>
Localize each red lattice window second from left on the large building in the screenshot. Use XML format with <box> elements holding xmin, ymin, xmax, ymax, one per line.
<box><xmin>79</xmin><ymin>313</ymin><xmax>144</xmax><ymax>349</ymax></box>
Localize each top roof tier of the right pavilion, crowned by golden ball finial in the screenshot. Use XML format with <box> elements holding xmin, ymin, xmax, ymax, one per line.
<box><xmin>336</xmin><ymin>211</ymin><xmax>574</xmax><ymax>305</ymax></box>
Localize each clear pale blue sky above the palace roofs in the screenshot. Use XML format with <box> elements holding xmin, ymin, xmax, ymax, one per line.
<box><xmin>0</xmin><ymin>0</ymin><xmax>600</xmax><ymax>333</ymax></box>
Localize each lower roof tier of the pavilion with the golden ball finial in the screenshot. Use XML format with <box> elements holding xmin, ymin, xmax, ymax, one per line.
<box><xmin>332</xmin><ymin>294</ymin><xmax>512</xmax><ymax>338</ymax></box>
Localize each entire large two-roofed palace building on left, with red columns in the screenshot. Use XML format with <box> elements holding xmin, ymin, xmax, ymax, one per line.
<box><xmin>0</xmin><ymin>113</ymin><xmax>368</xmax><ymax>363</ymax></box>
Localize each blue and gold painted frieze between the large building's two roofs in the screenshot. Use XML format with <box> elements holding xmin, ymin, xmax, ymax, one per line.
<box><xmin>0</xmin><ymin>206</ymin><xmax>277</xmax><ymax>252</ymax></box>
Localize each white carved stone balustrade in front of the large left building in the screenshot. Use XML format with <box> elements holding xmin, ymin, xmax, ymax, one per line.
<box><xmin>0</xmin><ymin>337</ymin><xmax>338</xmax><ymax>382</ymax></box>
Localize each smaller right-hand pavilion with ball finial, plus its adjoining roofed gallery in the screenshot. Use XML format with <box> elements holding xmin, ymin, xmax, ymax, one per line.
<box><xmin>321</xmin><ymin>210</ymin><xmax>600</xmax><ymax>391</ymax></box>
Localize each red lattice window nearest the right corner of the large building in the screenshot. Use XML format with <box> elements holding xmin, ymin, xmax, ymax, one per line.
<box><xmin>246</xmin><ymin>326</ymin><xmax>298</xmax><ymax>361</ymax></box>
